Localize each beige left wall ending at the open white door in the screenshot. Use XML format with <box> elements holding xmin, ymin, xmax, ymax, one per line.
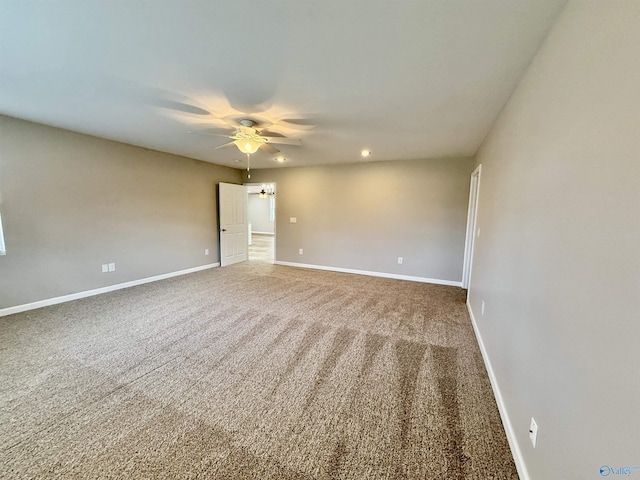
<box><xmin>0</xmin><ymin>117</ymin><xmax>241</xmax><ymax>308</ymax></box>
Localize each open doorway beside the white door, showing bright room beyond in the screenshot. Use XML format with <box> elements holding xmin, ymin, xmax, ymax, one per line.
<box><xmin>245</xmin><ymin>183</ymin><xmax>276</xmax><ymax>263</ymax></box>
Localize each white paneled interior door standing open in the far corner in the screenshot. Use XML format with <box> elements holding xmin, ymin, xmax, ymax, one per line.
<box><xmin>218</xmin><ymin>183</ymin><xmax>248</xmax><ymax>267</ymax></box>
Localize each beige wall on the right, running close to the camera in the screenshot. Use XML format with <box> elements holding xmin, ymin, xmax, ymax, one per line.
<box><xmin>470</xmin><ymin>0</ymin><xmax>640</xmax><ymax>479</ymax></box>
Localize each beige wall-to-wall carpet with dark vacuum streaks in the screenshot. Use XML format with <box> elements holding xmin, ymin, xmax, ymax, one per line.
<box><xmin>0</xmin><ymin>262</ymin><xmax>517</xmax><ymax>479</ymax></box>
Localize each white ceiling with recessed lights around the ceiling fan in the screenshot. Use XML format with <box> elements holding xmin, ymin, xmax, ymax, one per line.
<box><xmin>0</xmin><ymin>0</ymin><xmax>565</xmax><ymax>168</ymax></box>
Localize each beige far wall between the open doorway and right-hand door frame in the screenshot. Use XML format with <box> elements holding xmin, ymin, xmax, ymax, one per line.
<box><xmin>251</xmin><ymin>158</ymin><xmax>474</xmax><ymax>282</ymax></box>
